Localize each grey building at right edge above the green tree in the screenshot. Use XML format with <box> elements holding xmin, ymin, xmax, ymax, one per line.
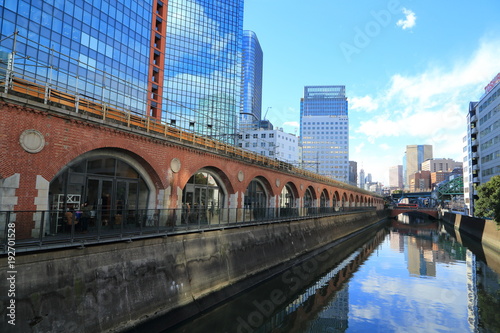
<box><xmin>464</xmin><ymin>73</ymin><xmax>500</xmax><ymax>215</ymax></box>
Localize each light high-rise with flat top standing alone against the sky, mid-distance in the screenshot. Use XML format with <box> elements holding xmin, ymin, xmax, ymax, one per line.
<box><xmin>300</xmin><ymin>86</ymin><xmax>349</xmax><ymax>182</ymax></box>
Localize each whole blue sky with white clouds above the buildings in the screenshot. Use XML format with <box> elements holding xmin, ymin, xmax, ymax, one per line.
<box><xmin>244</xmin><ymin>0</ymin><xmax>500</xmax><ymax>185</ymax></box>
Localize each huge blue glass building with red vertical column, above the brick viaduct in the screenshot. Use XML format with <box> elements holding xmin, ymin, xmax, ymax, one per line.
<box><xmin>0</xmin><ymin>0</ymin><xmax>243</xmax><ymax>142</ymax></box>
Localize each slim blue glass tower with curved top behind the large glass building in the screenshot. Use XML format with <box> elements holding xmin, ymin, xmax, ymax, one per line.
<box><xmin>240</xmin><ymin>30</ymin><xmax>263</xmax><ymax>131</ymax></box>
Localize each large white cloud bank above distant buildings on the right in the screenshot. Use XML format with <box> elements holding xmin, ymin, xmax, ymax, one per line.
<box><xmin>350</xmin><ymin>39</ymin><xmax>500</xmax><ymax>184</ymax></box>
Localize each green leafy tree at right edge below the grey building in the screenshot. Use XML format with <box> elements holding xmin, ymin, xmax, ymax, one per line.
<box><xmin>474</xmin><ymin>176</ymin><xmax>500</xmax><ymax>223</ymax></box>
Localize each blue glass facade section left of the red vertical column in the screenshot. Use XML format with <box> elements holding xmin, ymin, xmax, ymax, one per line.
<box><xmin>0</xmin><ymin>0</ymin><xmax>152</xmax><ymax>112</ymax></box>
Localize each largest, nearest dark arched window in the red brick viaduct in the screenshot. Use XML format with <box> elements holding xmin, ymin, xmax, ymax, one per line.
<box><xmin>45</xmin><ymin>152</ymin><xmax>150</xmax><ymax>233</ymax></box>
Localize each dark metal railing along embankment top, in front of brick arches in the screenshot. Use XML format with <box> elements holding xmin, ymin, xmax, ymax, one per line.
<box><xmin>0</xmin><ymin>207</ymin><xmax>376</xmax><ymax>255</ymax></box>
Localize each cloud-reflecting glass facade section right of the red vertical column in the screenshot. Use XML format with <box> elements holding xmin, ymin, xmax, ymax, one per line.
<box><xmin>162</xmin><ymin>0</ymin><xmax>243</xmax><ymax>143</ymax></box>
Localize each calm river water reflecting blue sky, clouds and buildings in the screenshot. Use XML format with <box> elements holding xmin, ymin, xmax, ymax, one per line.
<box><xmin>164</xmin><ymin>217</ymin><xmax>500</xmax><ymax>333</ymax></box>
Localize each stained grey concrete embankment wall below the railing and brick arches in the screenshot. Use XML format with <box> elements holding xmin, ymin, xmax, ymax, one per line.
<box><xmin>0</xmin><ymin>211</ymin><xmax>387</xmax><ymax>332</ymax></box>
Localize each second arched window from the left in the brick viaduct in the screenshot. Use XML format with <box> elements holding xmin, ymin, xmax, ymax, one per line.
<box><xmin>181</xmin><ymin>171</ymin><xmax>225</xmax><ymax>224</ymax></box>
